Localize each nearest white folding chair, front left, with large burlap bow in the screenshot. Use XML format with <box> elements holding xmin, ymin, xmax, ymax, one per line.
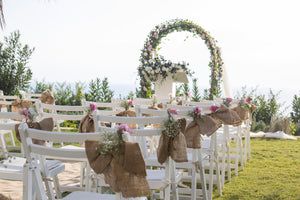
<box><xmin>19</xmin><ymin>124</ymin><xmax>120</xmax><ymax>200</ymax></box>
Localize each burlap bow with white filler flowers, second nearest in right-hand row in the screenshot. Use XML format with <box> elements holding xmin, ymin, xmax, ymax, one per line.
<box><xmin>157</xmin><ymin>118</ymin><xmax>188</xmax><ymax>164</ymax></box>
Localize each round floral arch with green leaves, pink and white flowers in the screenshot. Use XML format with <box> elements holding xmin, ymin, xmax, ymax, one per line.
<box><xmin>138</xmin><ymin>19</ymin><xmax>223</xmax><ymax>99</ymax></box>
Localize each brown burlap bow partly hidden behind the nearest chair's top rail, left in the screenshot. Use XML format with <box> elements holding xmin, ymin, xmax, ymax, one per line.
<box><xmin>15</xmin><ymin>118</ymin><xmax>54</xmax><ymax>146</ymax></box>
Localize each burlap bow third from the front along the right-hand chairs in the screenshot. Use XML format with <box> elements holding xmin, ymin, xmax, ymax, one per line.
<box><xmin>184</xmin><ymin>115</ymin><xmax>222</xmax><ymax>149</ymax></box>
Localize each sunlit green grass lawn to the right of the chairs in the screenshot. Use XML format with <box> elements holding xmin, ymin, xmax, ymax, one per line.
<box><xmin>213</xmin><ymin>138</ymin><xmax>300</xmax><ymax>200</ymax></box>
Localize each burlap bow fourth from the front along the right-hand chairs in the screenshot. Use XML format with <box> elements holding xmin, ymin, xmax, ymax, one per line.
<box><xmin>210</xmin><ymin>104</ymin><xmax>242</xmax><ymax>126</ymax></box>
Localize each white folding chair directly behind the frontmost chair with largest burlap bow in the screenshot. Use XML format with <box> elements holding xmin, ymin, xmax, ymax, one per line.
<box><xmin>93</xmin><ymin>111</ymin><xmax>181</xmax><ymax>200</ymax></box>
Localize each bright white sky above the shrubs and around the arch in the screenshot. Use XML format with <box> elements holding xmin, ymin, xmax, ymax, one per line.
<box><xmin>1</xmin><ymin>0</ymin><xmax>300</xmax><ymax>97</ymax></box>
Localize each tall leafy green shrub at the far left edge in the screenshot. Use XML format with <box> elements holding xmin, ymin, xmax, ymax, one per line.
<box><xmin>0</xmin><ymin>31</ymin><xmax>34</xmax><ymax>95</ymax></box>
